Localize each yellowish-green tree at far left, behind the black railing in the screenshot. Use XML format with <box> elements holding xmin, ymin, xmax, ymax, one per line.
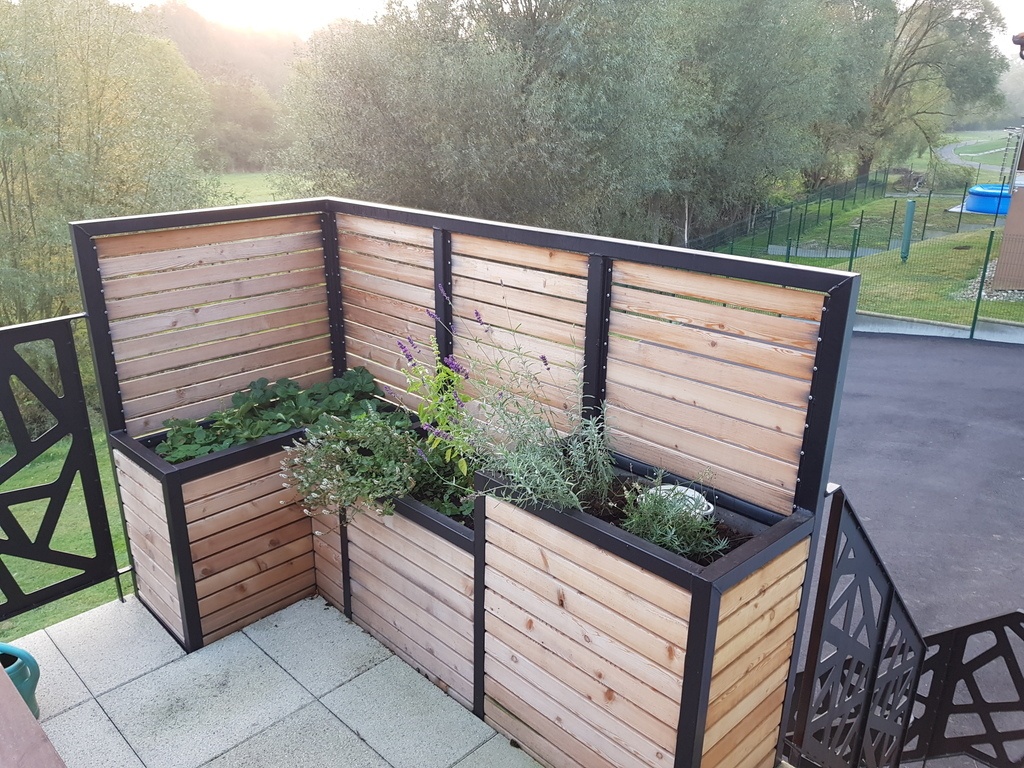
<box><xmin>0</xmin><ymin>0</ymin><xmax>211</xmax><ymax>325</ymax></box>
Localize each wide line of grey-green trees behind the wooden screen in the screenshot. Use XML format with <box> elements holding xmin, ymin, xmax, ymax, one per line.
<box><xmin>280</xmin><ymin>0</ymin><xmax>1007</xmax><ymax>243</ymax></box>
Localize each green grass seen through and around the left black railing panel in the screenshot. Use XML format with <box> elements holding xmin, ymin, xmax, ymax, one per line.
<box><xmin>0</xmin><ymin>430</ymin><xmax>131</xmax><ymax>641</ymax></box>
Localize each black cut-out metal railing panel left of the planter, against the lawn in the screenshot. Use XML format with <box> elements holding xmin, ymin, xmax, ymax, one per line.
<box><xmin>0</xmin><ymin>314</ymin><xmax>120</xmax><ymax>618</ymax></box>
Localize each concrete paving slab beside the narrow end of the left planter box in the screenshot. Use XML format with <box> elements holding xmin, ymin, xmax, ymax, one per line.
<box><xmin>46</xmin><ymin>597</ymin><xmax>184</xmax><ymax>695</ymax></box>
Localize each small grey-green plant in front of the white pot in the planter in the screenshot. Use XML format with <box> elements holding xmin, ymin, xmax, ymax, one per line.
<box><xmin>622</xmin><ymin>473</ymin><xmax>729</xmax><ymax>562</ymax></box>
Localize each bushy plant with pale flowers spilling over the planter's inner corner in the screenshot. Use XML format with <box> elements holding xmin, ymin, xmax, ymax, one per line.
<box><xmin>282</xmin><ymin>411</ymin><xmax>421</xmax><ymax>524</ymax></box>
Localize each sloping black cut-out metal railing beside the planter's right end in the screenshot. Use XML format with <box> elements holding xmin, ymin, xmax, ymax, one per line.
<box><xmin>786</xmin><ymin>489</ymin><xmax>925</xmax><ymax>768</ymax></box>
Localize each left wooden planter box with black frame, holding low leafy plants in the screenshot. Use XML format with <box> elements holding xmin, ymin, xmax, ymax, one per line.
<box><xmin>111</xmin><ymin>430</ymin><xmax>315</xmax><ymax>651</ymax></box>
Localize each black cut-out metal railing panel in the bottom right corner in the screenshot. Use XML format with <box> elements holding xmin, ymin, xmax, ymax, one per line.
<box><xmin>903</xmin><ymin>610</ymin><xmax>1024</xmax><ymax>768</ymax></box>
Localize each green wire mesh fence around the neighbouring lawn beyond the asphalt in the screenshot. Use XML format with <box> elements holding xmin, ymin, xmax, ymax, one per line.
<box><xmin>693</xmin><ymin>172</ymin><xmax>1024</xmax><ymax>333</ymax></box>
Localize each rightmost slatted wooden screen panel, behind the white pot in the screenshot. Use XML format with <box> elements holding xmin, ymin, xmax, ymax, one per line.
<box><xmin>605</xmin><ymin>261</ymin><xmax>824</xmax><ymax>514</ymax></box>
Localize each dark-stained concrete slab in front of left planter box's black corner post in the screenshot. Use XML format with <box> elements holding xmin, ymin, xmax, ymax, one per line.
<box><xmin>97</xmin><ymin>633</ymin><xmax>312</xmax><ymax>768</ymax></box>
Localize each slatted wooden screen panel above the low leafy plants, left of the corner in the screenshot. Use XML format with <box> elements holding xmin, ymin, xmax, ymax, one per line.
<box><xmin>93</xmin><ymin>214</ymin><xmax>332</xmax><ymax>436</ymax></box>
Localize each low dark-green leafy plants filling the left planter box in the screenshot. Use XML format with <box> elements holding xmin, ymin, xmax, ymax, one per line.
<box><xmin>155</xmin><ymin>368</ymin><xmax>382</xmax><ymax>464</ymax></box>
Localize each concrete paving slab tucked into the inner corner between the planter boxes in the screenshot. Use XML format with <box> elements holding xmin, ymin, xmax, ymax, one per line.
<box><xmin>243</xmin><ymin>597</ymin><xmax>391</xmax><ymax>697</ymax></box>
